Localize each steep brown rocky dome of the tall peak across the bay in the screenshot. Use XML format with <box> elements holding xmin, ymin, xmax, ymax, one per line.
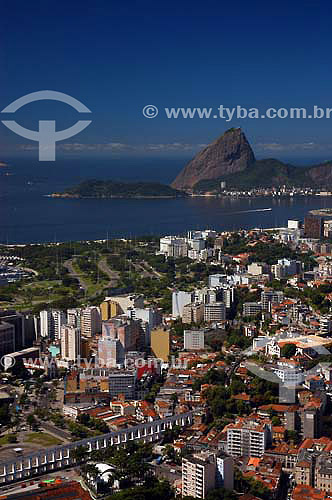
<box><xmin>171</xmin><ymin>128</ymin><xmax>255</xmax><ymax>189</ymax></box>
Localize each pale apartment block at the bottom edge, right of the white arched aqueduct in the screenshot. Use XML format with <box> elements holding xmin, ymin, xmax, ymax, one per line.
<box><xmin>182</xmin><ymin>453</ymin><xmax>216</xmax><ymax>498</ymax></box>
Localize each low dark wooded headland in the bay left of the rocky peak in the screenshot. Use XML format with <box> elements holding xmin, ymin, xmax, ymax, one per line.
<box><xmin>49</xmin><ymin>179</ymin><xmax>187</xmax><ymax>199</ymax></box>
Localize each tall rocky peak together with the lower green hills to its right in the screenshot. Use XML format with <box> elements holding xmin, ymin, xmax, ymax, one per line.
<box><xmin>171</xmin><ymin>128</ymin><xmax>332</xmax><ymax>193</ymax></box>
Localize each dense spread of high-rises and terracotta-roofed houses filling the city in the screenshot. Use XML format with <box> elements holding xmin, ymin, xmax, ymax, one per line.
<box><xmin>0</xmin><ymin>220</ymin><xmax>332</xmax><ymax>500</ymax></box>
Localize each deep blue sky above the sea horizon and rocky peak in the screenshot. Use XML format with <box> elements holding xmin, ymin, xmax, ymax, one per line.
<box><xmin>0</xmin><ymin>0</ymin><xmax>332</xmax><ymax>160</ymax></box>
